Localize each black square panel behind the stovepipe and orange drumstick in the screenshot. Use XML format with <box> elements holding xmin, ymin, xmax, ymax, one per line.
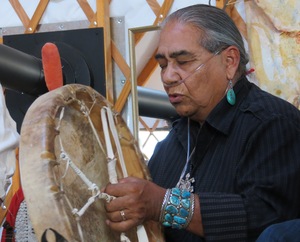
<box><xmin>0</xmin><ymin>28</ymin><xmax>106</xmax><ymax>131</ymax></box>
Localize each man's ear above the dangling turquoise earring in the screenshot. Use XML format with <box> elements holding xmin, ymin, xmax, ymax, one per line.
<box><xmin>222</xmin><ymin>46</ymin><xmax>240</xmax><ymax>80</ymax></box>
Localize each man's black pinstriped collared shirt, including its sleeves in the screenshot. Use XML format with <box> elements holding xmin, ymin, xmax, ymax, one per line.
<box><xmin>149</xmin><ymin>77</ymin><xmax>300</xmax><ymax>242</ymax></box>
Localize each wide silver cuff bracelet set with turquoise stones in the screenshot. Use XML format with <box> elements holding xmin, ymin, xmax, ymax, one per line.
<box><xmin>160</xmin><ymin>187</ymin><xmax>195</xmax><ymax>229</ymax></box>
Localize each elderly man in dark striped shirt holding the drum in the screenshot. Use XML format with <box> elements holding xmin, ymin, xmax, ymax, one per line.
<box><xmin>105</xmin><ymin>5</ymin><xmax>300</xmax><ymax>242</ymax></box>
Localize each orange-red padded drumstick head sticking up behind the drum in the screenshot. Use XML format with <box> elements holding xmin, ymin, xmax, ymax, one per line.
<box><xmin>42</xmin><ymin>42</ymin><xmax>63</xmax><ymax>91</ymax></box>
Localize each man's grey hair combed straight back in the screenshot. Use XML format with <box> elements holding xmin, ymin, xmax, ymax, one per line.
<box><xmin>161</xmin><ymin>4</ymin><xmax>249</xmax><ymax>74</ymax></box>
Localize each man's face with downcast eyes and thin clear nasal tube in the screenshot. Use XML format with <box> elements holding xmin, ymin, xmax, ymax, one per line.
<box><xmin>156</xmin><ymin>22</ymin><xmax>228</xmax><ymax>122</ymax></box>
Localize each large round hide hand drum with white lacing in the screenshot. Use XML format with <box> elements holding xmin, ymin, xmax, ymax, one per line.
<box><xmin>19</xmin><ymin>84</ymin><xmax>162</xmax><ymax>242</ymax></box>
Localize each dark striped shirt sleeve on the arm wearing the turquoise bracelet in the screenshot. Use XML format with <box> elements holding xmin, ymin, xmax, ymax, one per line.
<box><xmin>198</xmin><ymin>117</ymin><xmax>300</xmax><ymax>241</ymax></box>
